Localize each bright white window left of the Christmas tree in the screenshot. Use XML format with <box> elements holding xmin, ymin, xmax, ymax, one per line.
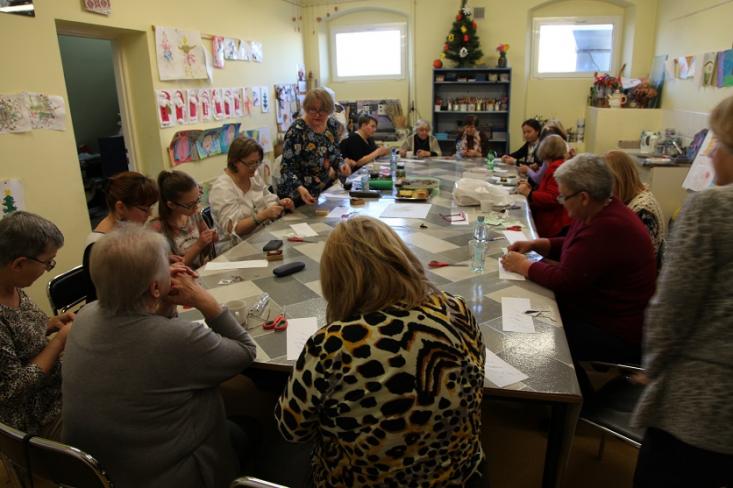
<box><xmin>331</xmin><ymin>23</ymin><xmax>406</xmax><ymax>81</ymax></box>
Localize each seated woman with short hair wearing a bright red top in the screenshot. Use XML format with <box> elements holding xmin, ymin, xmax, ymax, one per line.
<box><xmin>517</xmin><ymin>134</ymin><xmax>570</xmax><ymax>237</ymax></box>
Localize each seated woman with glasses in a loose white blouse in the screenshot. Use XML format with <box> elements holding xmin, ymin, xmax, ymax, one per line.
<box><xmin>209</xmin><ymin>136</ymin><xmax>294</xmax><ymax>250</ymax></box>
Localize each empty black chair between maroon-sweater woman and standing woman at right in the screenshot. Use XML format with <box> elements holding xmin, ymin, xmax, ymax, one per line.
<box><xmin>580</xmin><ymin>361</ymin><xmax>644</xmax><ymax>459</ymax></box>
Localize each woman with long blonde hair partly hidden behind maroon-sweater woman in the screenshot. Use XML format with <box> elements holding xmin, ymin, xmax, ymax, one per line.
<box><xmin>605</xmin><ymin>151</ymin><xmax>667</xmax><ymax>255</ymax></box>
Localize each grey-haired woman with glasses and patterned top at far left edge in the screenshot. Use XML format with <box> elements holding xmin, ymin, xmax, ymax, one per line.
<box><xmin>0</xmin><ymin>211</ymin><xmax>74</xmax><ymax>440</ymax></box>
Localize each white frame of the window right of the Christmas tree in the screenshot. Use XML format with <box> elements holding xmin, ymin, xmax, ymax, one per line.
<box><xmin>531</xmin><ymin>15</ymin><xmax>623</xmax><ymax>79</ymax></box>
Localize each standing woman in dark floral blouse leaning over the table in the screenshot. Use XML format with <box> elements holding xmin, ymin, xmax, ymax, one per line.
<box><xmin>277</xmin><ymin>88</ymin><xmax>351</xmax><ymax>205</ymax></box>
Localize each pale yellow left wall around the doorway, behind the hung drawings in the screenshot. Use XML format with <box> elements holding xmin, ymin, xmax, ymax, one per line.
<box><xmin>0</xmin><ymin>0</ymin><xmax>303</xmax><ymax>306</ymax></box>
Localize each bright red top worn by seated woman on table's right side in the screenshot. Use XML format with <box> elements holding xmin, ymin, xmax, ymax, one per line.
<box><xmin>529</xmin><ymin>159</ymin><xmax>570</xmax><ymax>237</ymax></box>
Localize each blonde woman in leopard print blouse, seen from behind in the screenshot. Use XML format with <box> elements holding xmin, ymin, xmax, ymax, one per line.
<box><xmin>275</xmin><ymin>217</ymin><xmax>485</xmax><ymax>487</ymax></box>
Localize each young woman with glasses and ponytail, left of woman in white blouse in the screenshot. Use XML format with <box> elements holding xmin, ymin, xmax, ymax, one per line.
<box><xmin>150</xmin><ymin>171</ymin><xmax>216</xmax><ymax>268</ymax></box>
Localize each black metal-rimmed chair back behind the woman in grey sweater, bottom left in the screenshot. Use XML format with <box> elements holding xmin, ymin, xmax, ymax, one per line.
<box><xmin>28</xmin><ymin>437</ymin><xmax>112</xmax><ymax>488</ymax></box>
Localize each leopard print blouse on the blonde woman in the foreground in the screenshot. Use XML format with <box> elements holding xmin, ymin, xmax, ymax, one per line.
<box><xmin>275</xmin><ymin>293</ymin><xmax>485</xmax><ymax>487</ymax></box>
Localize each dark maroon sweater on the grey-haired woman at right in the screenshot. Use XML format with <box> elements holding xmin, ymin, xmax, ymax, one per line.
<box><xmin>529</xmin><ymin>197</ymin><xmax>657</xmax><ymax>346</ymax></box>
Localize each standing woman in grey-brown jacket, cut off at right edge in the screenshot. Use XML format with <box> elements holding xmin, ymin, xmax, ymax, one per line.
<box><xmin>634</xmin><ymin>97</ymin><xmax>733</xmax><ymax>488</ymax></box>
